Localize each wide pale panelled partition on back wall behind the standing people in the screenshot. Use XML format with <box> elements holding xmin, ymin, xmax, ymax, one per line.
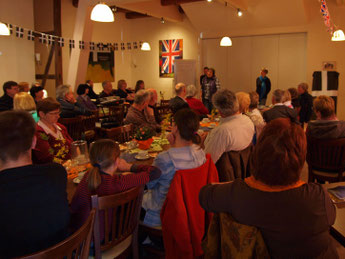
<box><xmin>202</xmin><ymin>33</ymin><xmax>307</xmax><ymax>102</ymax></box>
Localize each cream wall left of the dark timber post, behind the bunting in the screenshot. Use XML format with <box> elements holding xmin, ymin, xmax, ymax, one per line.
<box><xmin>0</xmin><ymin>0</ymin><xmax>35</xmax><ymax>95</ymax></box>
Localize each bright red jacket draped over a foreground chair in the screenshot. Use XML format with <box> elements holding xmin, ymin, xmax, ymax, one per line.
<box><xmin>161</xmin><ymin>154</ymin><xmax>218</xmax><ymax>259</ymax></box>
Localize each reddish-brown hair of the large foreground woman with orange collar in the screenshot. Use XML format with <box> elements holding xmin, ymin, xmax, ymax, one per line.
<box><xmin>253</xmin><ymin>118</ymin><xmax>307</xmax><ymax>186</ymax></box>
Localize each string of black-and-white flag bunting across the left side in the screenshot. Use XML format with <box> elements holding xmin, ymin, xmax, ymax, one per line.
<box><xmin>2</xmin><ymin>23</ymin><xmax>142</xmax><ymax>51</ymax></box>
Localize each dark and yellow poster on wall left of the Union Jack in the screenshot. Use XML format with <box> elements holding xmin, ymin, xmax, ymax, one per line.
<box><xmin>86</xmin><ymin>51</ymin><xmax>115</xmax><ymax>83</ymax></box>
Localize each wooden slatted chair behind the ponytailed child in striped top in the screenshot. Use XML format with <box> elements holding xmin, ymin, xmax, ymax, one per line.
<box><xmin>91</xmin><ymin>186</ymin><xmax>144</xmax><ymax>259</ymax></box>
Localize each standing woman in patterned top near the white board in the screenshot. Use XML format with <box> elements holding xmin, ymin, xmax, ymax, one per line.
<box><xmin>201</xmin><ymin>68</ymin><xmax>220</xmax><ymax>112</ymax></box>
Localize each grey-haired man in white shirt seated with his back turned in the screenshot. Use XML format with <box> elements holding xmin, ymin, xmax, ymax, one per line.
<box><xmin>205</xmin><ymin>89</ymin><xmax>254</xmax><ymax>163</ymax></box>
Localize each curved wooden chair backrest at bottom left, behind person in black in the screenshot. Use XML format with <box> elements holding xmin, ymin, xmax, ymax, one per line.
<box><xmin>20</xmin><ymin>209</ymin><xmax>96</xmax><ymax>259</ymax></box>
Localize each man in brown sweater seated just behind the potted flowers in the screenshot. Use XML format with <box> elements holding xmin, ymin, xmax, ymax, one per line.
<box><xmin>124</xmin><ymin>90</ymin><xmax>160</xmax><ymax>131</ymax></box>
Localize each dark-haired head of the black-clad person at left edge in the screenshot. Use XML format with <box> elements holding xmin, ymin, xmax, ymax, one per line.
<box><xmin>0</xmin><ymin>111</ymin><xmax>36</xmax><ymax>163</ymax></box>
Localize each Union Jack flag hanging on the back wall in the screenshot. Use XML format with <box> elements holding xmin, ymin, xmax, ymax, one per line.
<box><xmin>159</xmin><ymin>39</ymin><xmax>183</xmax><ymax>78</ymax></box>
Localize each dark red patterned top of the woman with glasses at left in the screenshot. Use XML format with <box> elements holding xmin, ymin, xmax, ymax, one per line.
<box><xmin>32</xmin><ymin>123</ymin><xmax>73</xmax><ymax>164</ymax></box>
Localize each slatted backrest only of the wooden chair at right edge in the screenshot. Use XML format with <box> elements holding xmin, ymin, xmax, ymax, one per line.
<box><xmin>307</xmin><ymin>137</ymin><xmax>345</xmax><ymax>173</ymax></box>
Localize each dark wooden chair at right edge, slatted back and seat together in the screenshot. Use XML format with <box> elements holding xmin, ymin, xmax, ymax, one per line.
<box><xmin>307</xmin><ymin>137</ymin><xmax>345</xmax><ymax>183</ymax></box>
